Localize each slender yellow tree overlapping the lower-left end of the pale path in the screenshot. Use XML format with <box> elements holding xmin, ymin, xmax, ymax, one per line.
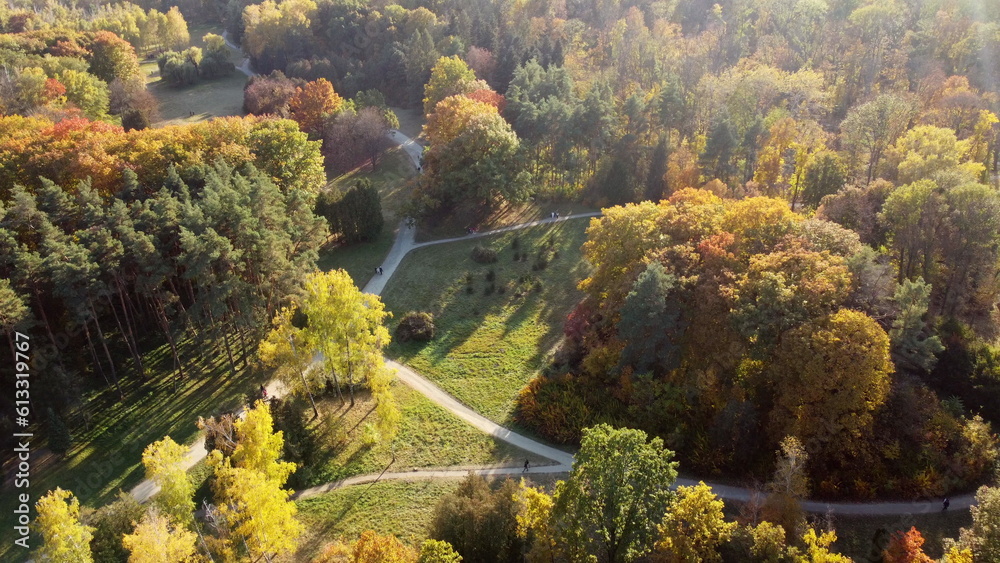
<box><xmin>142</xmin><ymin>436</ymin><xmax>194</xmax><ymax>525</ymax></box>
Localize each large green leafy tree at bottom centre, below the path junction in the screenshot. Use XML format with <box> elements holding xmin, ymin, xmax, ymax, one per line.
<box><xmin>552</xmin><ymin>424</ymin><xmax>677</xmax><ymax>562</ymax></box>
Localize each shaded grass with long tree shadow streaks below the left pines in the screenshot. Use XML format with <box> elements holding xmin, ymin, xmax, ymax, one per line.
<box><xmin>0</xmin><ymin>342</ymin><xmax>263</xmax><ymax>557</ymax></box>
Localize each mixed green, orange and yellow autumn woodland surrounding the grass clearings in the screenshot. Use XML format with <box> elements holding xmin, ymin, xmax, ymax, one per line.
<box><xmin>0</xmin><ymin>0</ymin><xmax>1000</xmax><ymax>561</ymax></box>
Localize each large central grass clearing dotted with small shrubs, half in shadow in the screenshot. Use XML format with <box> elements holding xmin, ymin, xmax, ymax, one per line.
<box><xmin>383</xmin><ymin>219</ymin><xmax>589</xmax><ymax>423</ymax></box>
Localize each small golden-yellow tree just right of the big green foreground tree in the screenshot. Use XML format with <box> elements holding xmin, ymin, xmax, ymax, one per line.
<box><xmin>654</xmin><ymin>482</ymin><xmax>736</xmax><ymax>562</ymax></box>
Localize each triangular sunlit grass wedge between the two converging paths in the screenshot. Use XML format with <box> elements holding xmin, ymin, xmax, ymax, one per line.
<box><xmin>292</xmin><ymin>383</ymin><xmax>551</xmax><ymax>486</ymax></box>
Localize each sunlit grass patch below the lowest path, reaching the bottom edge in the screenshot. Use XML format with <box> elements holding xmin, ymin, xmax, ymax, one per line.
<box><xmin>293</xmin><ymin>479</ymin><xmax>460</xmax><ymax>561</ymax></box>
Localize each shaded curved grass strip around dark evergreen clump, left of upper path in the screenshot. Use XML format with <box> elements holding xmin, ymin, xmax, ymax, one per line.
<box><xmin>319</xmin><ymin>147</ymin><xmax>415</xmax><ymax>287</ymax></box>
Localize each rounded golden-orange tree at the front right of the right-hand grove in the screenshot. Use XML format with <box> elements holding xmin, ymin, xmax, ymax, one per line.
<box><xmin>771</xmin><ymin>309</ymin><xmax>893</xmax><ymax>460</ymax></box>
